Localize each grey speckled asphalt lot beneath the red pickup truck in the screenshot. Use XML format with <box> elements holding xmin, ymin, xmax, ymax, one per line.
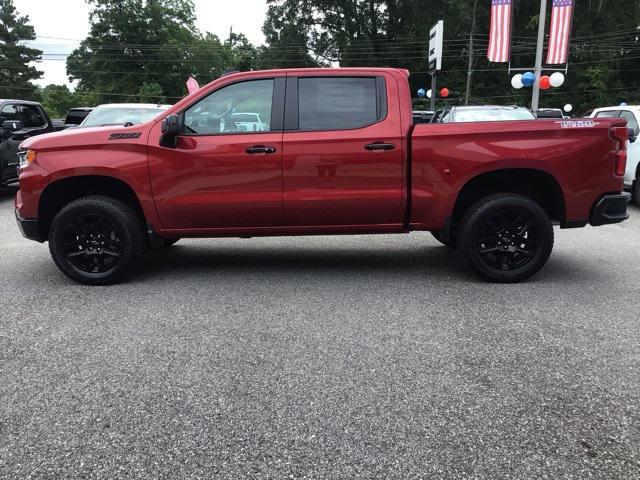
<box><xmin>0</xmin><ymin>185</ymin><xmax>640</xmax><ymax>479</ymax></box>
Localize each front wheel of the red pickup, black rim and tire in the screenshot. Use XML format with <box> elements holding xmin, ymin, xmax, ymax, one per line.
<box><xmin>49</xmin><ymin>196</ymin><xmax>145</xmax><ymax>285</ymax></box>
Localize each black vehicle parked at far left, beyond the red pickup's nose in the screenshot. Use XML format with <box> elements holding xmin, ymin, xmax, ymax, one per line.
<box><xmin>0</xmin><ymin>100</ymin><xmax>54</xmax><ymax>186</ymax></box>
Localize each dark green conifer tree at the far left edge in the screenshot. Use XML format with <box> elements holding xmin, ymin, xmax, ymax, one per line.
<box><xmin>0</xmin><ymin>0</ymin><xmax>42</xmax><ymax>99</ymax></box>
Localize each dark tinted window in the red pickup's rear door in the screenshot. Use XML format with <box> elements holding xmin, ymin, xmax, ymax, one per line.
<box><xmin>298</xmin><ymin>77</ymin><xmax>386</xmax><ymax>130</ymax></box>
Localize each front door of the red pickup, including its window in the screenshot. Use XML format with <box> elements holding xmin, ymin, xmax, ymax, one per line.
<box><xmin>149</xmin><ymin>77</ymin><xmax>285</xmax><ymax>233</ymax></box>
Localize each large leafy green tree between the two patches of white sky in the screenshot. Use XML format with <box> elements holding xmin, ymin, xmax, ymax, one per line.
<box><xmin>67</xmin><ymin>0</ymin><xmax>199</xmax><ymax>101</ymax></box>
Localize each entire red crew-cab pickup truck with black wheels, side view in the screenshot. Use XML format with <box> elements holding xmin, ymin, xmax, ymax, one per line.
<box><xmin>15</xmin><ymin>68</ymin><xmax>629</xmax><ymax>285</ymax></box>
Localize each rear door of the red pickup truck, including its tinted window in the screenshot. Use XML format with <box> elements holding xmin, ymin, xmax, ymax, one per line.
<box><xmin>283</xmin><ymin>72</ymin><xmax>405</xmax><ymax>226</ymax></box>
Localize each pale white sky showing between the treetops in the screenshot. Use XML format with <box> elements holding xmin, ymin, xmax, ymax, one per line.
<box><xmin>13</xmin><ymin>0</ymin><xmax>267</xmax><ymax>87</ymax></box>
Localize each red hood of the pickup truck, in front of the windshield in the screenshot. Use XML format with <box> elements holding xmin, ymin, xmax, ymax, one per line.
<box><xmin>19</xmin><ymin>122</ymin><xmax>154</xmax><ymax>150</ymax></box>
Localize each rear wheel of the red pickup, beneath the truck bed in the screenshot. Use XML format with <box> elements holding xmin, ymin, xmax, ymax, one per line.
<box><xmin>458</xmin><ymin>194</ymin><xmax>554</xmax><ymax>283</ymax></box>
